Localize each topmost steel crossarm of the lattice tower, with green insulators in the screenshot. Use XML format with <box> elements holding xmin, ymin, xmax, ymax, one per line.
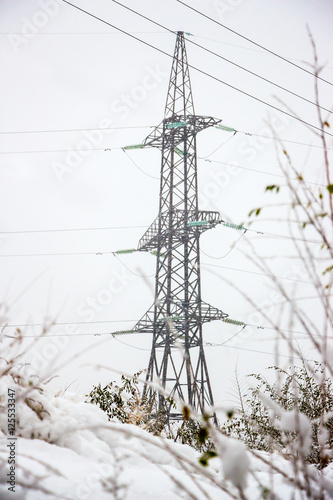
<box><xmin>143</xmin><ymin>115</ymin><xmax>222</xmax><ymax>149</ymax></box>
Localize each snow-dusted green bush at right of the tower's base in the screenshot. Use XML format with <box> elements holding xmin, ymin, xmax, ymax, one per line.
<box><xmin>223</xmin><ymin>364</ymin><xmax>333</xmax><ymax>468</ymax></box>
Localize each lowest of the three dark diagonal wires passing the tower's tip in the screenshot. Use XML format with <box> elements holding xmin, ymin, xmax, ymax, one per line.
<box><xmin>62</xmin><ymin>0</ymin><xmax>333</xmax><ymax>137</ymax></box>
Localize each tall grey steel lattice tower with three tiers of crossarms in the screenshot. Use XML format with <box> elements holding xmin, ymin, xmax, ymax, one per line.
<box><xmin>134</xmin><ymin>32</ymin><xmax>228</xmax><ymax>419</ymax></box>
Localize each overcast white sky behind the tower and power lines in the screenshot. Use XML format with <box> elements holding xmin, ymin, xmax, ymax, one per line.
<box><xmin>0</xmin><ymin>0</ymin><xmax>333</xmax><ymax>403</ymax></box>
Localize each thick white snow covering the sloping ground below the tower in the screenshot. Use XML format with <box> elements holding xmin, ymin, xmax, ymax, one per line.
<box><xmin>0</xmin><ymin>372</ymin><xmax>333</xmax><ymax>500</ymax></box>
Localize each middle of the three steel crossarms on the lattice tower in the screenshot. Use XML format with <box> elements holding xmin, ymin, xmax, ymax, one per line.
<box><xmin>138</xmin><ymin>210</ymin><xmax>223</xmax><ymax>251</ymax></box>
